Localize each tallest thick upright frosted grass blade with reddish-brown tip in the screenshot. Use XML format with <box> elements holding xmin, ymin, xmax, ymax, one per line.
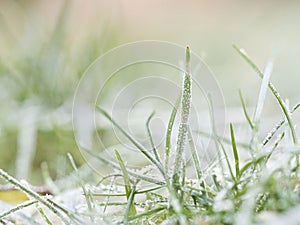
<box><xmin>173</xmin><ymin>46</ymin><xmax>192</xmax><ymax>184</ymax></box>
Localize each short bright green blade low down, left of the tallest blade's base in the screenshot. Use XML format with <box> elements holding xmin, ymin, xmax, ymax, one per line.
<box><xmin>115</xmin><ymin>150</ymin><xmax>136</xmax><ymax>218</ymax></box>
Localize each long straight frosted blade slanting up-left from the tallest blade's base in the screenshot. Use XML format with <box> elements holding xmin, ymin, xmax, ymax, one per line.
<box><xmin>97</xmin><ymin>106</ymin><xmax>165</xmax><ymax>177</ymax></box>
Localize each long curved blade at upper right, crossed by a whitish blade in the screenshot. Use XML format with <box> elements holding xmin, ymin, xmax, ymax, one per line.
<box><xmin>233</xmin><ymin>45</ymin><xmax>298</xmax><ymax>144</ymax></box>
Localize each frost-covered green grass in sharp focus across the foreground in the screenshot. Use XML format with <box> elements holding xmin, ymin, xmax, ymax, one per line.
<box><xmin>0</xmin><ymin>46</ymin><xmax>300</xmax><ymax>225</ymax></box>
